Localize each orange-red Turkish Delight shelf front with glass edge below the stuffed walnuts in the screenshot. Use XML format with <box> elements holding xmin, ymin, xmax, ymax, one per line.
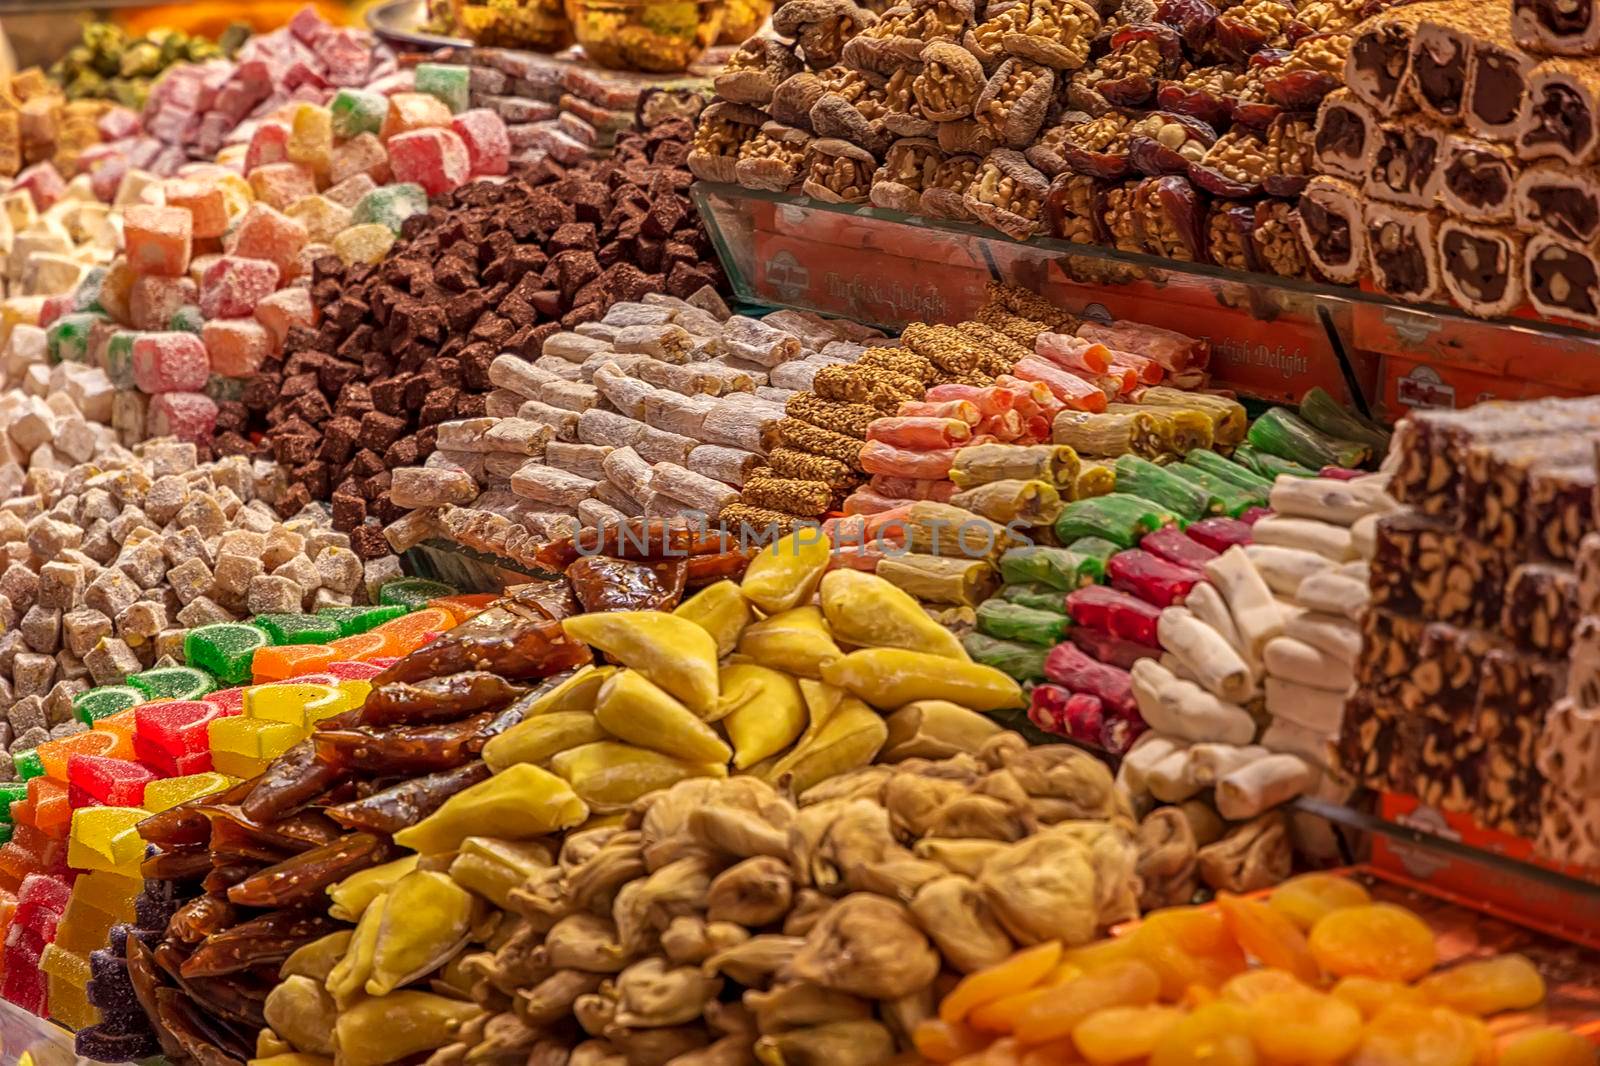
<box><xmin>690</xmin><ymin>181</ymin><xmax>1600</xmax><ymax>406</ymax></box>
